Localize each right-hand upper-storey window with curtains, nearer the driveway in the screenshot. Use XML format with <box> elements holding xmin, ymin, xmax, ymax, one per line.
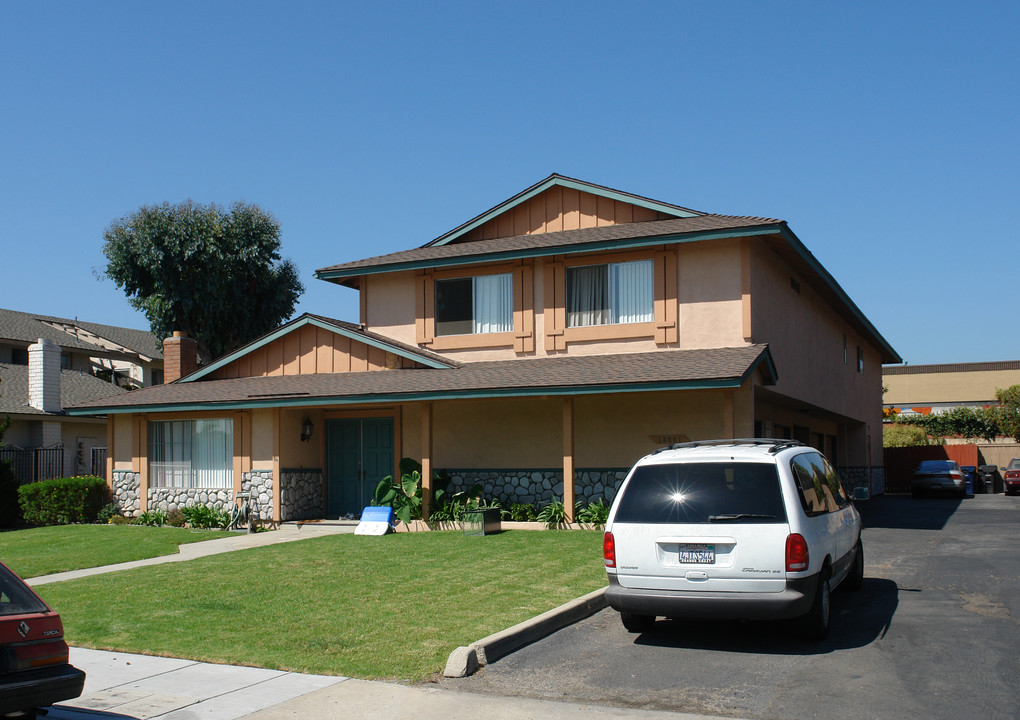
<box><xmin>566</xmin><ymin>260</ymin><xmax>654</xmax><ymax>327</ymax></box>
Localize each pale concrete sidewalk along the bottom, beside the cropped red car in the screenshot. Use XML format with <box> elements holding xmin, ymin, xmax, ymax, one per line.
<box><xmin>47</xmin><ymin>648</ymin><xmax>730</xmax><ymax>720</ymax></box>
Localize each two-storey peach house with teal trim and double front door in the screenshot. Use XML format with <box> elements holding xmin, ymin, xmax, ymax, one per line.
<box><xmin>71</xmin><ymin>174</ymin><xmax>901</xmax><ymax>521</ymax></box>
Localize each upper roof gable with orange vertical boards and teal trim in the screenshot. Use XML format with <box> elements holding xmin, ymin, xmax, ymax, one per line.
<box><xmin>422</xmin><ymin>173</ymin><xmax>704</xmax><ymax>247</ymax></box>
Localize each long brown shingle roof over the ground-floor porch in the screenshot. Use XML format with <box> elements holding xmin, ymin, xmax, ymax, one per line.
<box><xmin>65</xmin><ymin>345</ymin><xmax>774</xmax><ymax>412</ymax></box>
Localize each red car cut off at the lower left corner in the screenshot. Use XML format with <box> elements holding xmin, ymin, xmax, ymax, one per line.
<box><xmin>0</xmin><ymin>563</ymin><xmax>85</xmax><ymax>718</ymax></box>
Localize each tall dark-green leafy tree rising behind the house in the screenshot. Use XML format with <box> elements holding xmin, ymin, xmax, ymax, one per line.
<box><xmin>103</xmin><ymin>200</ymin><xmax>304</xmax><ymax>361</ymax></box>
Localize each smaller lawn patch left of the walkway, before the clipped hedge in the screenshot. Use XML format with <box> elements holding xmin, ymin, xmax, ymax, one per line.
<box><xmin>0</xmin><ymin>525</ymin><xmax>231</xmax><ymax>577</ymax></box>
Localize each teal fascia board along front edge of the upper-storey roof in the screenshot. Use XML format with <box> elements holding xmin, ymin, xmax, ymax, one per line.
<box><xmin>315</xmin><ymin>223</ymin><xmax>785</xmax><ymax>282</ymax></box>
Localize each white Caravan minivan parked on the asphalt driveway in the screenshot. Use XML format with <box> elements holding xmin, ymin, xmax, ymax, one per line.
<box><xmin>603</xmin><ymin>439</ymin><xmax>864</xmax><ymax>639</ymax></box>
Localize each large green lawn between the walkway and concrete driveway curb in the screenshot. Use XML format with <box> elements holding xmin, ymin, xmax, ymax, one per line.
<box><xmin>35</xmin><ymin>530</ymin><xmax>606</xmax><ymax>681</ymax></box>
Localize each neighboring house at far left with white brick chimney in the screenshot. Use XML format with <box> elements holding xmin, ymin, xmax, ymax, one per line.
<box><xmin>0</xmin><ymin>309</ymin><xmax>162</xmax><ymax>481</ymax></box>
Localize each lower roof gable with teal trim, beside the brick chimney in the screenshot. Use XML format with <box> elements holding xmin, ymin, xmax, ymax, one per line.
<box><xmin>179</xmin><ymin>313</ymin><xmax>453</xmax><ymax>382</ymax></box>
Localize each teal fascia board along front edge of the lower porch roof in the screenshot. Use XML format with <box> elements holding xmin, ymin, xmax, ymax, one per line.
<box><xmin>67</xmin><ymin>373</ymin><xmax>749</xmax><ymax>415</ymax></box>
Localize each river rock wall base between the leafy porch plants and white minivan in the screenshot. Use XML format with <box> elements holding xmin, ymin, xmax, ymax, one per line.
<box><xmin>446</xmin><ymin>468</ymin><xmax>628</xmax><ymax>508</ymax></box>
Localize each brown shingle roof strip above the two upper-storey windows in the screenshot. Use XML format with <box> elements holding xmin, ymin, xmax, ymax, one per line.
<box><xmin>315</xmin><ymin>215</ymin><xmax>783</xmax><ymax>276</ymax></box>
